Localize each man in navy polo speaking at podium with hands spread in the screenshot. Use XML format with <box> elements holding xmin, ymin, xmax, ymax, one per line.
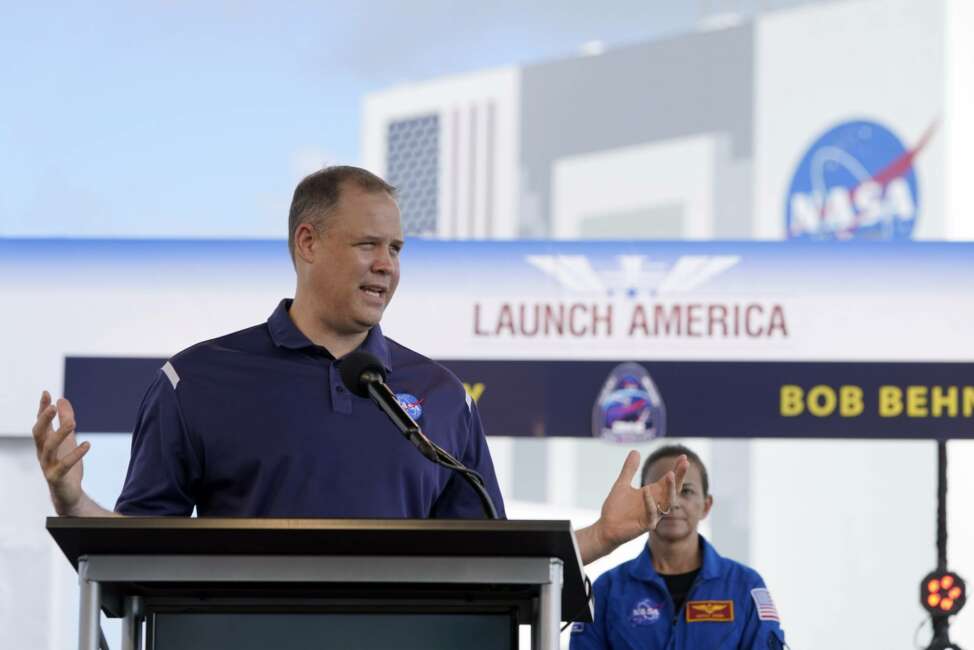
<box><xmin>33</xmin><ymin>167</ymin><xmax>688</xmax><ymax>562</ymax></box>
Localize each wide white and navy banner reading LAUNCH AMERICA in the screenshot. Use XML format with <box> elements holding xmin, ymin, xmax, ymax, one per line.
<box><xmin>0</xmin><ymin>239</ymin><xmax>974</xmax><ymax>441</ymax></box>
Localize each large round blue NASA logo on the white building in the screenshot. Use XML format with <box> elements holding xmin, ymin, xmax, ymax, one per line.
<box><xmin>785</xmin><ymin>120</ymin><xmax>936</xmax><ymax>240</ymax></box>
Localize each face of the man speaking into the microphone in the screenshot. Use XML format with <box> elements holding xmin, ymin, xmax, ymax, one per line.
<box><xmin>309</xmin><ymin>183</ymin><xmax>403</xmax><ymax>336</ymax></box>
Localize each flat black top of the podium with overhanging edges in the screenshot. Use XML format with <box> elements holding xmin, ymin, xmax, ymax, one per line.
<box><xmin>47</xmin><ymin>517</ymin><xmax>587</xmax><ymax>618</ymax></box>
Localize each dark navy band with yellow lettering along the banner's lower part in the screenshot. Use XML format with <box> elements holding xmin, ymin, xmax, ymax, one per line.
<box><xmin>64</xmin><ymin>357</ymin><xmax>974</xmax><ymax>439</ymax></box>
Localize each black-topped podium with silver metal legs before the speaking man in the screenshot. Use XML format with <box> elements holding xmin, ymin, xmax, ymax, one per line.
<box><xmin>47</xmin><ymin>517</ymin><xmax>592</xmax><ymax>650</ymax></box>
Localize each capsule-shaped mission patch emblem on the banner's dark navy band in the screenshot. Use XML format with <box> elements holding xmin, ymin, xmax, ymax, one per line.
<box><xmin>592</xmin><ymin>363</ymin><xmax>666</xmax><ymax>443</ymax></box>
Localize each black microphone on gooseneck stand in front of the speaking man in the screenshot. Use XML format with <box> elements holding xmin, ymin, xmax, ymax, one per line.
<box><xmin>338</xmin><ymin>350</ymin><xmax>497</xmax><ymax>519</ymax></box>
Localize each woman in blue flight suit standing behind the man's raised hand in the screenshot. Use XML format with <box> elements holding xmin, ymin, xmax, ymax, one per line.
<box><xmin>570</xmin><ymin>445</ymin><xmax>786</xmax><ymax>650</ymax></box>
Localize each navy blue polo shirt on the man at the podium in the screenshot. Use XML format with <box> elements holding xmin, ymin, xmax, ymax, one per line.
<box><xmin>115</xmin><ymin>300</ymin><xmax>504</xmax><ymax>518</ymax></box>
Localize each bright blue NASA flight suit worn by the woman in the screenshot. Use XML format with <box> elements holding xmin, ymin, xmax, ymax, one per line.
<box><xmin>570</xmin><ymin>536</ymin><xmax>784</xmax><ymax>650</ymax></box>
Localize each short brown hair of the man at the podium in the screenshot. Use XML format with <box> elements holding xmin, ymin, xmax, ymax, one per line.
<box><xmin>287</xmin><ymin>165</ymin><xmax>396</xmax><ymax>260</ymax></box>
